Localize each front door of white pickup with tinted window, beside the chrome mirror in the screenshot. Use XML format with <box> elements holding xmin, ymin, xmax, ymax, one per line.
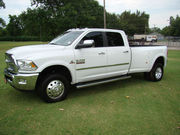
<box><xmin>75</xmin><ymin>32</ymin><xmax>107</xmax><ymax>82</ymax></box>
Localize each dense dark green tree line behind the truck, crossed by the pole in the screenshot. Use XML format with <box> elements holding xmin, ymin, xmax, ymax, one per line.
<box><xmin>3</xmin><ymin>0</ymin><xmax>149</xmax><ymax>40</ymax></box>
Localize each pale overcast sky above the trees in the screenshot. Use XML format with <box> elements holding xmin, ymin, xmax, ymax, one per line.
<box><xmin>0</xmin><ymin>0</ymin><xmax>180</xmax><ymax>28</ymax></box>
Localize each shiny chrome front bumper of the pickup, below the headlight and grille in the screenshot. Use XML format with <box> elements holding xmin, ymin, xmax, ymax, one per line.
<box><xmin>4</xmin><ymin>69</ymin><xmax>39</xmax><ymax>90</ymax></box>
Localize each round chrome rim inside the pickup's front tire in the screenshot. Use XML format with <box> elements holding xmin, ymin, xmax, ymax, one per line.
<box><xmin>46</xmin><ymin>80</ymin><xmax>65</xmax><ymax>99</ymax></box>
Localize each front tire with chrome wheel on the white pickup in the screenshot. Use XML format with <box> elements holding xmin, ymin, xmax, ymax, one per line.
<box><xmin>38</xmin><ymin>74</ymin><xmax>70</xmax><ymax>103</ymax></box>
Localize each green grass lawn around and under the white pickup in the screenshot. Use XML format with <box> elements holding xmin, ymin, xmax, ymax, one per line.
<box><xmin>0</xmin><ymin>42</ymin><xmax>180</xmax><ymax>135</ymax></box>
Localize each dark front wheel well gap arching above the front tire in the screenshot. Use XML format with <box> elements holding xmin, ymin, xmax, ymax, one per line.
<box><xmin>36</xmin><ymin>65</ymin><xmax>72</xmax><ymax>88</ymax></box>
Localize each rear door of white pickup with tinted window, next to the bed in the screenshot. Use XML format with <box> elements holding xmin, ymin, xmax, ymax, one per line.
<box><xmin>105</xmin><ymin>32</ymin><xmax>131</xmax><ymax>76</ymax></box>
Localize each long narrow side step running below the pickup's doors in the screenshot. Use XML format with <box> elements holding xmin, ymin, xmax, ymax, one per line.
<box><xmin>76</xmin><ymin>75</ymin><xmax>131</xmax><ymax>88</ymax></box>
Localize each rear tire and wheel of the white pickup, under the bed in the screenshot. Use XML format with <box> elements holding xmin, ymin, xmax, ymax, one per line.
<box><xmin>144</xmin><ymin>63</ymin><xmax>164</xmax><ymax>82</ymax></box>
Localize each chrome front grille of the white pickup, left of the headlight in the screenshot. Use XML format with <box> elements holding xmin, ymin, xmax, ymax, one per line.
<box><xmin>5</xmin><ymin>53</ymin><xmax>17</xmax><ymax>73</ymax></box>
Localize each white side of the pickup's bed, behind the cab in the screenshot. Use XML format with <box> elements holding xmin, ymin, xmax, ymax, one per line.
<box><xmin>129</xmin><ymin>45</ymin><xmax>167</xmax><ymax>73</ymax></box>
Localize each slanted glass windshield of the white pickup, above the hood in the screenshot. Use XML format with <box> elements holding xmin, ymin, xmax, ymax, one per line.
<box><xmin>50</xmin><ymin>31</ymin><xmax>83</xmax><ymax>46</ymax></box>
